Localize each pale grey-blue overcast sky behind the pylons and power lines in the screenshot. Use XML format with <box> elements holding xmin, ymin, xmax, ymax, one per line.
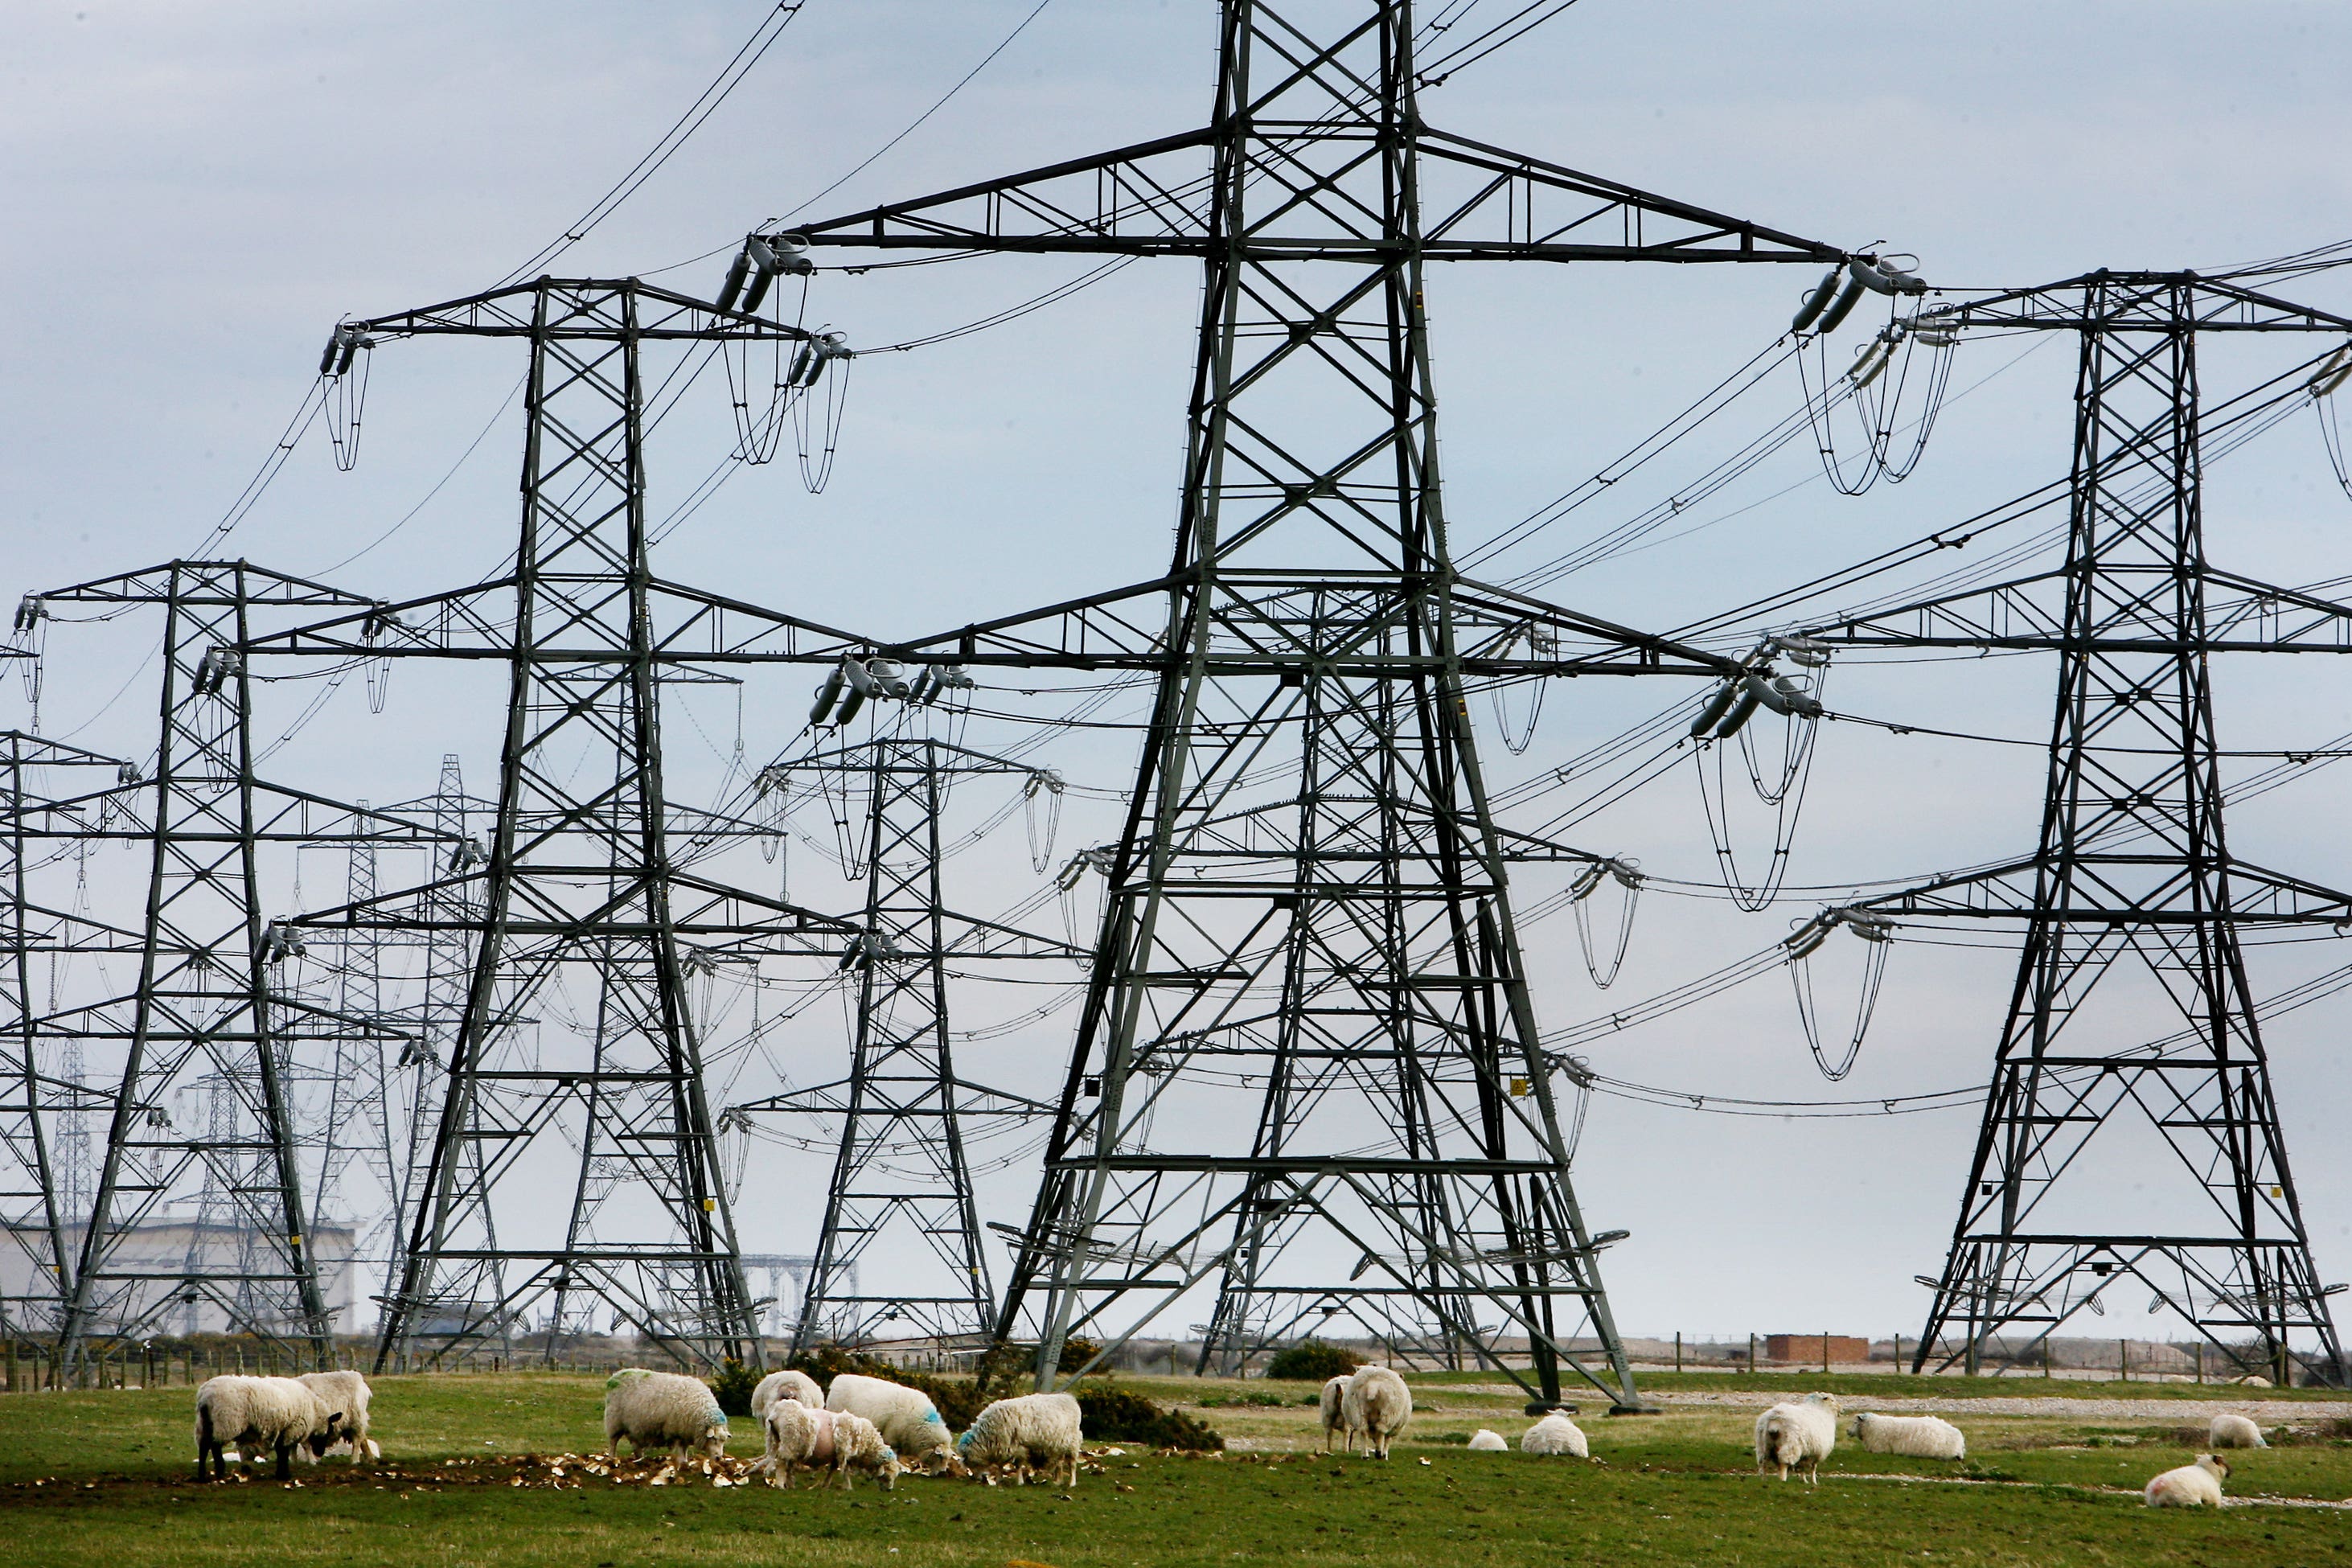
<box><xmin>0</xmin><ymin>0</ymin><xmax>2352</xmax><ymax>1336</ymax></box>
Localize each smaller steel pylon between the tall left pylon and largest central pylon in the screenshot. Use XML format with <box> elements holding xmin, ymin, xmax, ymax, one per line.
<box><xmin>732</xmin><ymin>733</ymin><xmax>1086</xmax><ymax>1354</ymax></box>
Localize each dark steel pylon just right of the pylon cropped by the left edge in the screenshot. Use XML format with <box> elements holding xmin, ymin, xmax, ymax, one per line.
<box><xmin>12</xmin><ymin>562</ymin><xmax>454</xmax><ymax>1364</ymax></box>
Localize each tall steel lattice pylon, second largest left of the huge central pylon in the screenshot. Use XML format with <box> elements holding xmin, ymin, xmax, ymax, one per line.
<box><xmin>252</xmin><ymin>277</ymin><xmax>875</xmax><ymax>1366</ymax></box>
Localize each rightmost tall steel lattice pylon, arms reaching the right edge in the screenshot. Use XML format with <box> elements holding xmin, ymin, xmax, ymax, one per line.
<box><xmin>1811</xmin><ymin>273</ymin><xmax>2352</xmax><ymax>1380</ymax></box>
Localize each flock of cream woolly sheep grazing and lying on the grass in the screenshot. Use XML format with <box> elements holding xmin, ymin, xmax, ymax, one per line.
<box><xmin>195</xmin><ymin>1366</ymin><xmax>2265</xmax><ymax>1507</ymax></box>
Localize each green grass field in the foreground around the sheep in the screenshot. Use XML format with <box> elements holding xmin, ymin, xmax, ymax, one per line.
<box><xmin>0</xmin><ymin>1373</ymin><xmax>2352</xmax><ymax>1568</ymax></box>
